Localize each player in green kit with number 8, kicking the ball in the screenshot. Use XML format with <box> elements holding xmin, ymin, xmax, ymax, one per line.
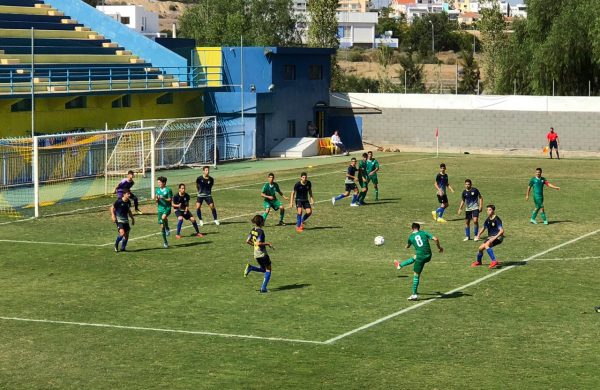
<box><xmin>394</xmin><ymin>222</ymin><xmax>444</xmax><ymax>301</ymax></box>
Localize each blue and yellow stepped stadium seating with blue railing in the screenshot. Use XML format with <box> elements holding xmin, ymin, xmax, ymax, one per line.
<box><xmin>0</xmin><ymin>0</ymin><xmax>188</xmax><ymax>94</ymax></box>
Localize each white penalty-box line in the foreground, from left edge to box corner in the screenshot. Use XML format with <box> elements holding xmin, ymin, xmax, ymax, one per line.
<box><xmin>0</xmin><ymin>317</ymin><xmax>323</xmax><ymax>344</ymax></box>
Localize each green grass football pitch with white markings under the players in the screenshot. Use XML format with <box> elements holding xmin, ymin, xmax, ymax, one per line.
<box><xmin>0</xmin><ymin>153</ymin><xmax>600</xmax><ymax>389</ymax></box>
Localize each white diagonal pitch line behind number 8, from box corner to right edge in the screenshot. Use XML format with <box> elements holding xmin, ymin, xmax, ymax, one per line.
<box><xmin>323</xmin><ymin>229</ymin><xmax>600</xmax><ymax>344</ymax></box>
